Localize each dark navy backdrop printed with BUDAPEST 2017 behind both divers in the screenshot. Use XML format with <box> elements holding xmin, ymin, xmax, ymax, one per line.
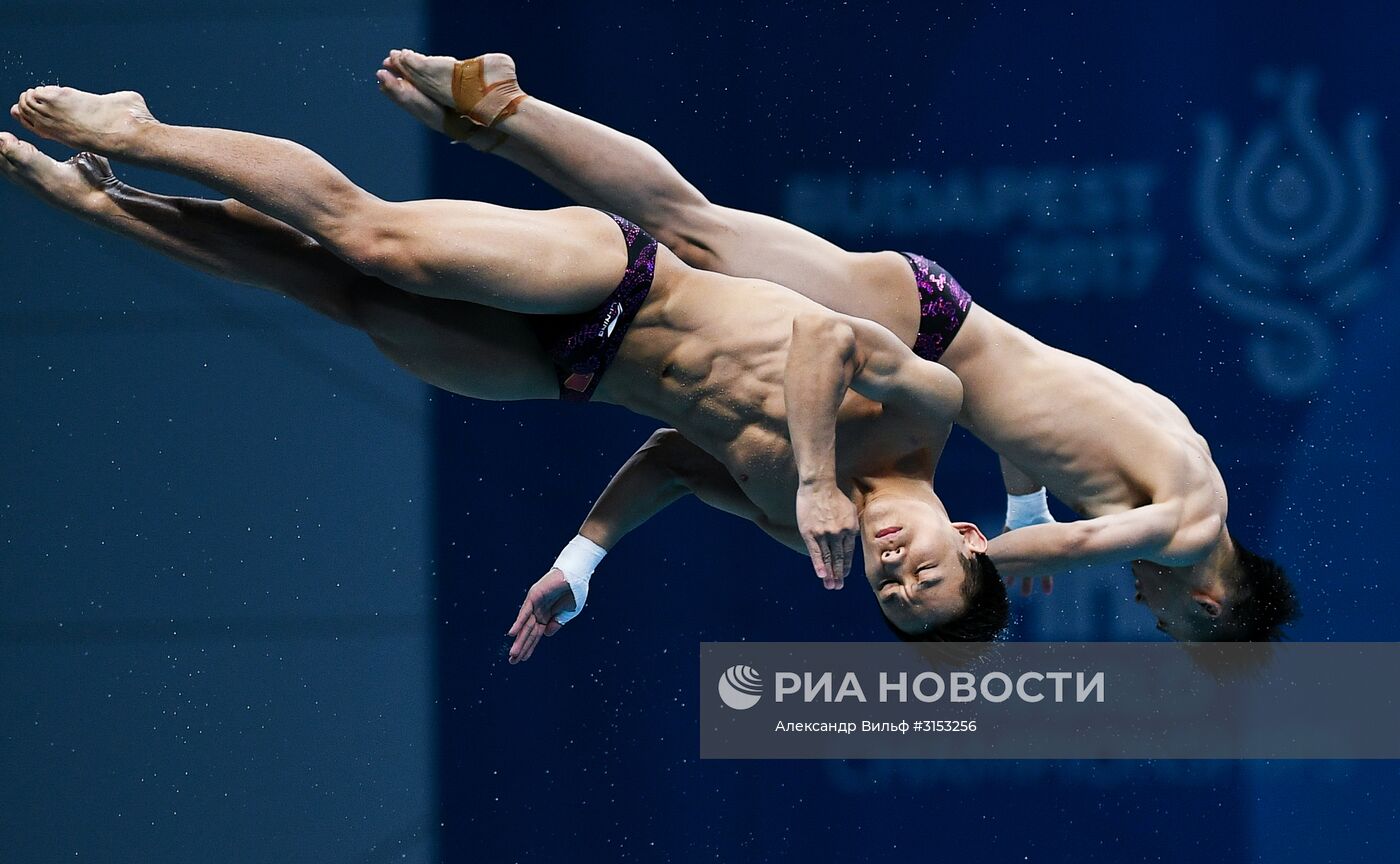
<box><xmin>428</xmin><ymin>0</ymin><xmax>1400</xmax><ymax>861</ymax></box>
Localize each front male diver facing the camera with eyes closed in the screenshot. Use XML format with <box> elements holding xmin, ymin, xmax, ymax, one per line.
<box><xmin>0</xmin><ymin>87</ymin><xmax>1008</xmax><ymax>662</ymax></box>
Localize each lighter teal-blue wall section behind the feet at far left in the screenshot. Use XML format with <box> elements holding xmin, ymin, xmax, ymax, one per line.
<box><xmin>0</xmin><ymin>0</ymin><xmax>437</xmax><ymax>864</ymax></box>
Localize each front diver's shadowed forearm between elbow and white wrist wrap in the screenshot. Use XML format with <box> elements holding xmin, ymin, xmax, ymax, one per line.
<box><xmin>578</xmin><ymin>430</ymin><xmax>690</xmax><ymax>549</ymax></box>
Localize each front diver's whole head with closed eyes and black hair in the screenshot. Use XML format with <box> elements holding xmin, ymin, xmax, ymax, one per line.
<box><xmin>861</xmin><ymin>484</ymin><xmax>1011</xmax><ymax>641</ymax></box>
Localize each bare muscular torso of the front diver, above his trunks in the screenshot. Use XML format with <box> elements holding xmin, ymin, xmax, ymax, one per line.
<box><xmin>598</xmin><ymin>253</ymin><xmax>942</xmax><ymax>527</ymax></box>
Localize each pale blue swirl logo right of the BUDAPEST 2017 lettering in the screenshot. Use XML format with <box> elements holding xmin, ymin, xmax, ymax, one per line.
<box><xmin>1196</xmin><ymin>71</ymin><xmax>1383</xmax><ymax>398</ymax></box>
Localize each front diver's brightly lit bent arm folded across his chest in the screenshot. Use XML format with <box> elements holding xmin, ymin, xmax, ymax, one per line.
<box><xmin>784</xmin><ymin>312</ymin><xmax>962</xmax><ymax>588</ymax></box>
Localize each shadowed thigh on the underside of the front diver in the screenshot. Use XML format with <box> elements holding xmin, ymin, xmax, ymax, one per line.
<box><xmin>357</xmin><ymin>283</ymin><xmax>559</xmax><ymax>402</ymax></box>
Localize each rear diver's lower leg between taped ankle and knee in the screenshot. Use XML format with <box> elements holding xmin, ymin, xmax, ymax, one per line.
<box><xmin>491</xmin><ymin>98</ymin><xmax>708</xmax><ymax>234</ymax></box>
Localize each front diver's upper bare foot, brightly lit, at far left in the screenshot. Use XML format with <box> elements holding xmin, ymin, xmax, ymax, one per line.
<box><xmin>10</xmin><ymin>87</ymin><xmax>155</xmax><ymax>154</ymax></box>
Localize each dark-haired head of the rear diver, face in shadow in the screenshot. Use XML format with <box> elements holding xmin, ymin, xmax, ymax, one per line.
<box><xmin>1133</xmin><ymin>535</ymin><xmax>1299</xmax><ymax>641</ymax></box>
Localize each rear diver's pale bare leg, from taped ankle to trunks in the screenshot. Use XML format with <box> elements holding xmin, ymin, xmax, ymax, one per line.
<box><xmin>377</xmin><ymin>50</ymin><xmax>918</xmax><ymax>340</ymax></box>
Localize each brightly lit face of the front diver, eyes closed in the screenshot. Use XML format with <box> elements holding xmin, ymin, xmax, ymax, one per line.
<box><xmin>861</xmin><ymin>499</ymin><xmax>987</xmax><ymax>634</ymax></box>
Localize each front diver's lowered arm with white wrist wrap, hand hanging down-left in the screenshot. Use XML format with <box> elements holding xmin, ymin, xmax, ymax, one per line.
<box><xmin>508</xmin><ymin>428</ymin><xmax>802</xmax><ymax>664</ymax></box>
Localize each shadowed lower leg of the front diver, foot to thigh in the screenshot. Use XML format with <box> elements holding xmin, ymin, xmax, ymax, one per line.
<box><xmin>0</xmin><ymin>132</ymin><xmax>557</xmax><ymax>399</ymax></box>
